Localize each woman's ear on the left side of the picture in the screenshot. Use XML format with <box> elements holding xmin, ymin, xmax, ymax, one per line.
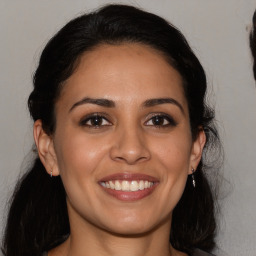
<box><xmin>34</xmin><ymin>120</ymin><xmax>59</xmax><ymax>176</ymax></box>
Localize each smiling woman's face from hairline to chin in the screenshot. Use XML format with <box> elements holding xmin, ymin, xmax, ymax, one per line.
<box><xmin>36</xmin><ymin>43</ymin><xmax>203</xmax><ymax>234</ymax></box>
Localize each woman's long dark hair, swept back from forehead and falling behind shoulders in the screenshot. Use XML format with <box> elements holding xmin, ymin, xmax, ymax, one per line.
<box><xmin>2</xmin><ymin>5</ymin><xmax>218</xmax><ymax>256</ymax></box>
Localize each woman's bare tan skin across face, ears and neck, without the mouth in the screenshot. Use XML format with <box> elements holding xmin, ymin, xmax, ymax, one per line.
<box><xmin>34</xmin><ymin>43</ymin><xmax>205</xmax><ymax>256</ymax></box>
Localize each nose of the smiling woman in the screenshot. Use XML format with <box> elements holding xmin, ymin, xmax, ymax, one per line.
<box><xmin>110</xmin><ymin>126</ymin><xmax>150</xmax><ymax>165</ymax></box>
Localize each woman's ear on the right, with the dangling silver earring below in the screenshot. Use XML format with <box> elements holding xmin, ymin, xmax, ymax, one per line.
<box><xmin>189</xmin><ymin>129</ymin><xmax>206</xmax><ymax>174</ymax></box>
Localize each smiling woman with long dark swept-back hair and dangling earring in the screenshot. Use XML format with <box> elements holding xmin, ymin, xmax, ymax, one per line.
<box><xmin>3</xmin><ymin>5</ymin><xmax>218</xmax><ymax>256</ymax></box>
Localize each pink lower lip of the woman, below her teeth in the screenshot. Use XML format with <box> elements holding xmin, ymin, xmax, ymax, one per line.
<box><xmin>101</xmin><ymin>183</ymin><xmax>157</xmax><ymax>201</ymax></box>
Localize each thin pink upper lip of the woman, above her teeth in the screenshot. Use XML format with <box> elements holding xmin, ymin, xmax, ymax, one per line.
<box><xmin>100</xmin><ymin>172</ymin><xmax>158</xmax><ymax>182</ymax></box>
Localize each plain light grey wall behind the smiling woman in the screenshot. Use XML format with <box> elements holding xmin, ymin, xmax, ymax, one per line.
<box><xmin>0</xmin><ymin>0</ymin><xmax>256</xmax><ymax>256</ymax></box>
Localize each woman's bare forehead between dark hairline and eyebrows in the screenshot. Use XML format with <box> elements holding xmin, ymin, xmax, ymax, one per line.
<box><xmin>60</xmin><ymin>43</ymin><xmax>186</xmax><ymax>110</ymax></box>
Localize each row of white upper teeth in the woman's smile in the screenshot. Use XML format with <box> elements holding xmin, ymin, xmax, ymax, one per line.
<box><xmin>101</xmin><ymin>180</ymin><xmax>154</xmax><ymax>191</ymax></box>
